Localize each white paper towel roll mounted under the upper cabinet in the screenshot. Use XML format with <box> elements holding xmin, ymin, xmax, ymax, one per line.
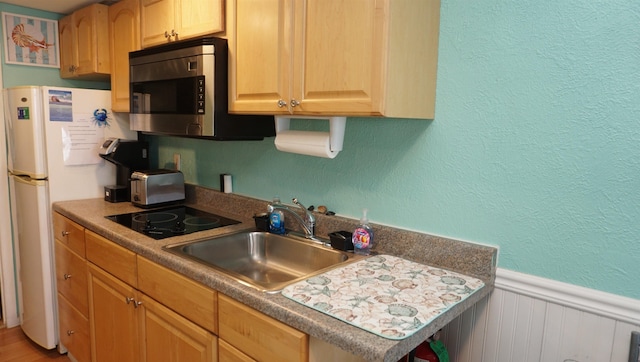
<box><xmin>275</xmin><ymin>131</ymin><xmax>338</xmax><ymax>158</ymax></box>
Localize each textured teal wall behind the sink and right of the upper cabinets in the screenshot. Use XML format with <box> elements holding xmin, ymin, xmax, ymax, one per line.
<box><xmin>152</xmin><ymin>0</ymin><xmax>640</xmax><ymax>299</ymax></box>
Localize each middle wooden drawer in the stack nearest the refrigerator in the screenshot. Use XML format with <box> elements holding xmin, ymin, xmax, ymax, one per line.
<box><xmin>56</xmin><ymin>240</ymin><xmax>89</xmax><ymax>317</ymax></box>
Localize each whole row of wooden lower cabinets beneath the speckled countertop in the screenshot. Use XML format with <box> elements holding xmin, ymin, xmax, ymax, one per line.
<box><xmin>55</xmin><ymin>223</ymin><xmax>361</xmax><ymax>362</ymax></box>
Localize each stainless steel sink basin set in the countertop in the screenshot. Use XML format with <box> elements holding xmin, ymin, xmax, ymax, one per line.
<box><xmin>164</xmin><ymin>230</ymin><xmax>354</xmax><ymax>293</ymax></box>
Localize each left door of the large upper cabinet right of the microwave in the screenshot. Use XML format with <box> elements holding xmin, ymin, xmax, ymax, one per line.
<box><xmin>227</xmin><ymin>0</ymin><xmax>293</xmax><ymax>114</ymax></box>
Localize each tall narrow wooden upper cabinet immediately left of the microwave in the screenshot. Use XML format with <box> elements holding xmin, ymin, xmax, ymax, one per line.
<box><xmin>109</xmin><ymin>0</ymin><xmax>140</xmax><ymax>112</ymax></box>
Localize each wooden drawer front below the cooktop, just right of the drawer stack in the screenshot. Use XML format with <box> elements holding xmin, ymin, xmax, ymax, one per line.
<box><xmin>85</xmin><ymin>230</ymin><xmax>138</xmax><ymax>287</ymax></box>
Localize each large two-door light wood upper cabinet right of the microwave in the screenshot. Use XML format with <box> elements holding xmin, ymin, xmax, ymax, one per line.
<box><xmin>227</xmin><ymin>0</ymin><xmax>440</xmax><ymax>119</ymax></box>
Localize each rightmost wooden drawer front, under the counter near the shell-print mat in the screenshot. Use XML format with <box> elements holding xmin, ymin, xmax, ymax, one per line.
<box><xmin>218</xmin><ymin>294</ymin><xmax>309</xmax><ymax>361</ymax></box>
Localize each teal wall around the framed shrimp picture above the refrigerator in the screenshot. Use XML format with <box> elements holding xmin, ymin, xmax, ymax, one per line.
<box><xmin>0</xmin><ymin>3</ymin><xmax>111</xmax><ymax>89</ymax></box>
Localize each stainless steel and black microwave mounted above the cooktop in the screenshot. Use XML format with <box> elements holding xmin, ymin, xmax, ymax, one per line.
<box><xmin>129</xmin><ymin>37</ymin><xmax>275</xmax><ymax>140</ymax></box>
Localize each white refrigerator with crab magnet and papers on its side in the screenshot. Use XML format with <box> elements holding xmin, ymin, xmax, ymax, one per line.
<box><xmin>0</xmin><ymin>87</ymin><xmax>137</xmax><ymax>349</ymax></box>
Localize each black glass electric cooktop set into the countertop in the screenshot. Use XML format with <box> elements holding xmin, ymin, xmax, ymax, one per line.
<box><xmin>106</xmin><ymin>206</ymin><xmax>240</xmax><ymax>240</ymax></box>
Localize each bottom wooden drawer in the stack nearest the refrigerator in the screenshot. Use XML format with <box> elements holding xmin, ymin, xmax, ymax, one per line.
<box><xmin>58</xmin><ymin>293</ymin><xmax>91</xmax><ymax>362</ymax></box>
